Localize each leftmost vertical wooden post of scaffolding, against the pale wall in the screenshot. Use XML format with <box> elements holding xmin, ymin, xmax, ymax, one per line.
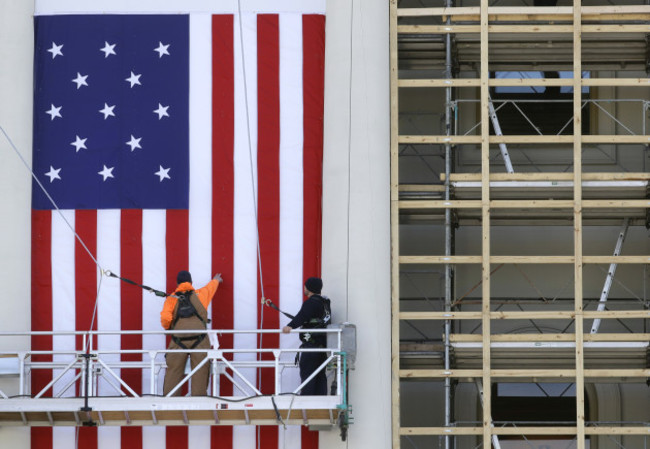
<box><xmin>390</xmin><ymin>0</ymin><xmax>400</xmax><ymax>449</ymax></box>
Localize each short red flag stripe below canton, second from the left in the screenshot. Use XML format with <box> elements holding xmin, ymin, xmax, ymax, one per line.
<box><xmin>74</xmin><ymin>210</ymin><xmax>97</xmax><ymax>449</ymax></box>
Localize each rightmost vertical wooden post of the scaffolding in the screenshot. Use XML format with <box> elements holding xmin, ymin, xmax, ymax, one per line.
<box><xmin>573</xmin><ymin>0</ymin><xmax>585</xmax><ymax>449</ymax></box>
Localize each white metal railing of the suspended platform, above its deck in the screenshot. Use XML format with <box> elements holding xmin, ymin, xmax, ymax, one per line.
<box><xmin>0</xmin><ymin>328</ymin><xmax>346</xmax><ymax>401</ymax></box>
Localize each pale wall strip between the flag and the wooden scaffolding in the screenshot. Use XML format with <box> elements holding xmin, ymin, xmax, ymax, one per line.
<box><xmin>321</xmin><ymin>0</ymin><xmax>391</xmax><ymax>449</ymax></box>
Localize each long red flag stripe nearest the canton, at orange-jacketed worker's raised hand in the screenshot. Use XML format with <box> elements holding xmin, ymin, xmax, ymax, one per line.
<box><xmin>210</xmin><ymin>15</ymin><xmax>235</xmax><ymax>449</ymax></box>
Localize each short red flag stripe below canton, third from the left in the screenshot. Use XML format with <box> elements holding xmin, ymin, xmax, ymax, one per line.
<box><xmin>120</xmin><ymin>209</ymin><xmax>143</xmax><ymax>448</ymax></box>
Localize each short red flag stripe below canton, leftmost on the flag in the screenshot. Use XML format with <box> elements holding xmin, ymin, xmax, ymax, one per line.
<box><xmin>31</xmin><ymin>210</ymin><xmax>52</xmax><ymax>449</ymax></box>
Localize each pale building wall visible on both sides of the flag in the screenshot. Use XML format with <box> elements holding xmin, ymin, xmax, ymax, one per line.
<box><xmin>0</xmin><ymin>0</ymin><xmax>391</xmax><ymax>449</ymax></box>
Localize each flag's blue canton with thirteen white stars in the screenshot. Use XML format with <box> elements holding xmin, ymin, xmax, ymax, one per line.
<box><xmin>32</xmin><ymin>15</ymin><xmax>189</xmax><ymax>209</ymax></box>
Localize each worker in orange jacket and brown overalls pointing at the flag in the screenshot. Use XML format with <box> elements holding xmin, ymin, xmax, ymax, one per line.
<box><xmin>160</xmin><ymin>271</ymin><xmax>223</xmax><ymax>396</ymax></box>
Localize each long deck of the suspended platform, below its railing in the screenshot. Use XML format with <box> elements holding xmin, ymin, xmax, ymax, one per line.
<box><xmin>0</xmin><ymin>395</ymin><xmax>341</xmax><ymax>427</ymax></box>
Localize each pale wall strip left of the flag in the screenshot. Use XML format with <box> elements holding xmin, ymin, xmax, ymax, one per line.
<box><xmin>0</xmin><ymin>0</ymin><xmax>33</xmax><ymax>448</ymax></box>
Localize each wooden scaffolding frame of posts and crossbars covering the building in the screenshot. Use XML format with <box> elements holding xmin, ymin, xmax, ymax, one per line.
<box><xmin>390</xmin><ymin>0</ymin><xmax>650</xmax><ymax>449</ymax></box>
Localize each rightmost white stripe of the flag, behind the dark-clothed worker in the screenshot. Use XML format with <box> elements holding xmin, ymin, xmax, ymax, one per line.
<box><xmin>278</xmin><ymin>14</ymin><xmax>303</xmax><ymax>448</ymax></box>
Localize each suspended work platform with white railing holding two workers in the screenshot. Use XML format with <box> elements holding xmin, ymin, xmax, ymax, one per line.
<box><xmin>0</xmin><ymin>324</ymin><xmax>356</xmax><ymax>436</ymax></box>
